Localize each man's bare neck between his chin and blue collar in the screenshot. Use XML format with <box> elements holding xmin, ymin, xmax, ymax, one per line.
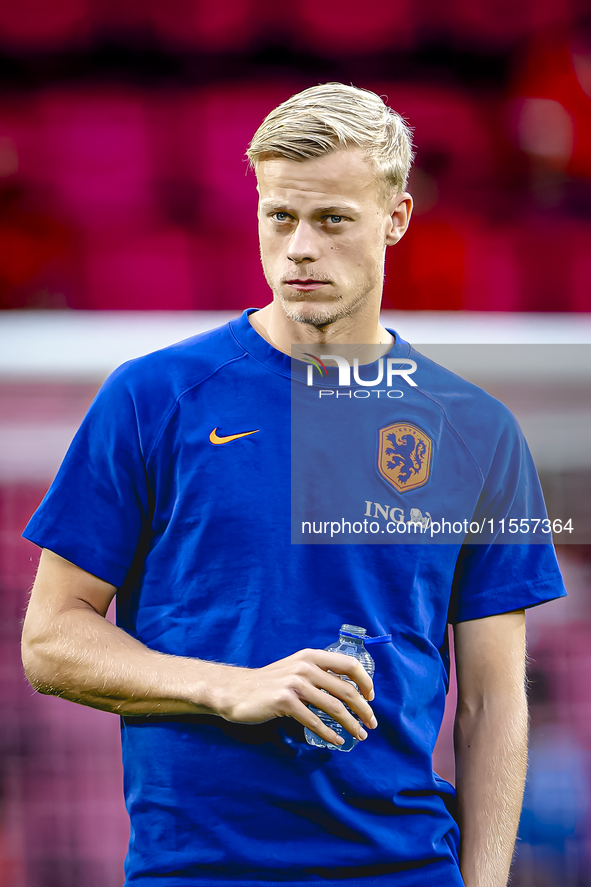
<box><xmin>249</xmin><ymin>302</ymin><xmax>392</xmax><ymax>354</ymax></box>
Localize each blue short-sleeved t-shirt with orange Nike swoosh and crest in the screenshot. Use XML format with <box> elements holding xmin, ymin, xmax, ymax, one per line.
<box><xmin>24</xmin><ymin>312</ymin><xmax>565</xmax><ymax>887</ymax></box>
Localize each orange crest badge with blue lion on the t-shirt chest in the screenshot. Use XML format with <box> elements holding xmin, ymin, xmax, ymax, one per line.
<box><xmin>378</xmin><ymin>422</ymin><xmax>433</xmax><ymax>493</ymax></box>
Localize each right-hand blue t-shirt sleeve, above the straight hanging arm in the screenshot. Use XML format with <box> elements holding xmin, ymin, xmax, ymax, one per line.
<box><xmin>449</xmin><ymin>410</ymin><xmax>566</xmax><ymax>622</ymax></box>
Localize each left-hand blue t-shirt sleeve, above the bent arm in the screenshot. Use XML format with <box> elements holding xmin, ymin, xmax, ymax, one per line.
<box><xmin>23</xmin><ymin>364</ymin><xmax>153</xmax><ymax>587</ymax></box>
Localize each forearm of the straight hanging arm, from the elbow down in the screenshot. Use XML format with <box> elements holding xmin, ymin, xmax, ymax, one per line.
<box><xmin>454</xmin><ymin>690</ymin><xmax>528</xmax><ymax>887</ymax></box>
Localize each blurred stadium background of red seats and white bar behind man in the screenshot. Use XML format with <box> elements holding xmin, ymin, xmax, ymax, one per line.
<box><xmin>0</xmin><ymin>0</ymin><xmax>591</xmax><ymax>887</ymax></box>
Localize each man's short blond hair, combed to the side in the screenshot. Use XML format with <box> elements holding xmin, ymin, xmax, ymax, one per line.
<box><xmin>246</xmin><ymin>83</ymin><xmax>414</xmax><ymax>192</ymax></box>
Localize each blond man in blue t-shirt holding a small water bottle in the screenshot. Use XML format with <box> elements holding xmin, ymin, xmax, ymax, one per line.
<box><xmin>23</xmin><ymin>84</ymin><xmax>564</xmax><ymax>887</ymax></box>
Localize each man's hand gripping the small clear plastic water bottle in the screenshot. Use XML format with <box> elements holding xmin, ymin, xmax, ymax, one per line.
<box><xmin>212</xmin><ymin>650</ymin><xmax>377</xmax><ymax>745</ymax></box>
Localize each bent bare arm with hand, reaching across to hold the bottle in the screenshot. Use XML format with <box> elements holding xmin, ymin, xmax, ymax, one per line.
<box><xmin>22</xmin><ymin>550</ymin><xmax>376</xmax><ymax>744</ymax></box>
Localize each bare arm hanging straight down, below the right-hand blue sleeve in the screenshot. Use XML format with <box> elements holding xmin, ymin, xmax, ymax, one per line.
<box><xmin>454</xmin><ymin>610</ymin><xmax>528</xmax><ymax>887</ymax></box>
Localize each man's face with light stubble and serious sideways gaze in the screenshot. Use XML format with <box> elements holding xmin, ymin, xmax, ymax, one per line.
<box><xmin>257</xmin><ymin>148</ymin><xmax>403</xmax><ymax>326</ymax></box>
